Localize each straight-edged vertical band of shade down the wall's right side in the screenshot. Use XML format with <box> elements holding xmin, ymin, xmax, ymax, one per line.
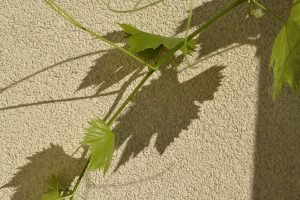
<box><xmin>253</xmin><ymin>1</ymin><xmax>300</xmax><ymax>200</ymax></box>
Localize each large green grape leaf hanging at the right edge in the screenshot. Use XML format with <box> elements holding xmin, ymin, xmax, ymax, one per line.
<box><xmin>270</xmin><ymin>0</ymin><xmax>300</xmax><ymax>100</ymax></box>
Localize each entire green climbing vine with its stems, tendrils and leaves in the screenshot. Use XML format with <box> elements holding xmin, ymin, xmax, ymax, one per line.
<box><xmin>42</xmin><ymin>0</ymin><xmax>300</xmax><ymax>200</ymax></box>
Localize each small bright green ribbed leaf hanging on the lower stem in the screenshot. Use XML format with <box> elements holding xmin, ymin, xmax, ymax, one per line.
<box><xmin>82</xmin><ymin>118</ymin><xmax>115</xmax><ymax>174</ymax></box>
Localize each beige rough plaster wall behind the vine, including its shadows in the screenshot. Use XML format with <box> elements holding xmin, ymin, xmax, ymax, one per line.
<box><xmin>0</xmin><ymin>0</ymin><xmax>300</xmax><ymax>200</ymax></box>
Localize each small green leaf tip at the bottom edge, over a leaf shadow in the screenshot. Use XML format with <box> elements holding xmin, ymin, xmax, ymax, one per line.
<box><xmin>42</xmin><ymin>176</ymin><xmax>62</xmax><ymax>200</ymax></box>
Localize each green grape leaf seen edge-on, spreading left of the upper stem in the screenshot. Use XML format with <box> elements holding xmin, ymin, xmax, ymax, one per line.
<box><xmin>119</xmin><ymin>24</ymin><xmax>196</xmax><ymax>59</ymax></box>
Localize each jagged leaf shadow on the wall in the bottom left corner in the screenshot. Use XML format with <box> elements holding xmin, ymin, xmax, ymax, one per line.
<box><xmin>0</xmin><ymin>144</ymin><xmax>87</xmax><ymax>200</ymax></box>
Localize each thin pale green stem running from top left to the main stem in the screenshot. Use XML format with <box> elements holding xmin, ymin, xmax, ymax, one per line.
<box><xmin>44</xmin><ymin>0</ymin><xmax>156</xmax><ymax>70</ymax></box>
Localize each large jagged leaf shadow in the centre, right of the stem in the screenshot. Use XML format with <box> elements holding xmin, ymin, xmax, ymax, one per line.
<box><xmin>114</xmin><ymin>66</ymin><xmax>224</xmax><ymax>171</ymax></box>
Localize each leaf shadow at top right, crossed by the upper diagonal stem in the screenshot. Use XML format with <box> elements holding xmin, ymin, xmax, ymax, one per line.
<box><xmin>176</xmin><ymin>0</ymin><xmax>264</xmax><ymax>58</ymax></box>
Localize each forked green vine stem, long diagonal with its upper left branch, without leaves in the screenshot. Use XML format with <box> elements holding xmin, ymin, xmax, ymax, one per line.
<box><xmin>45</xmin><ymin>0</ymin><xmax>247</xmax><ymax>200</ymax></box>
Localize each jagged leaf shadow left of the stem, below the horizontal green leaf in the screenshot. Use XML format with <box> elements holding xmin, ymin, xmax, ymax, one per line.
<box><xmin>77</xmin><ymin>31</ymin><xmax>145</xmax><ymax>120</ymax></box>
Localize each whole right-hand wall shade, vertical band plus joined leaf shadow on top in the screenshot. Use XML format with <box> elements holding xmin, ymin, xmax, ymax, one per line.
<box><xmin>178</xmin><ymin>0</ymin><xmax>300</xmax><ymax>200</ymax></box>
